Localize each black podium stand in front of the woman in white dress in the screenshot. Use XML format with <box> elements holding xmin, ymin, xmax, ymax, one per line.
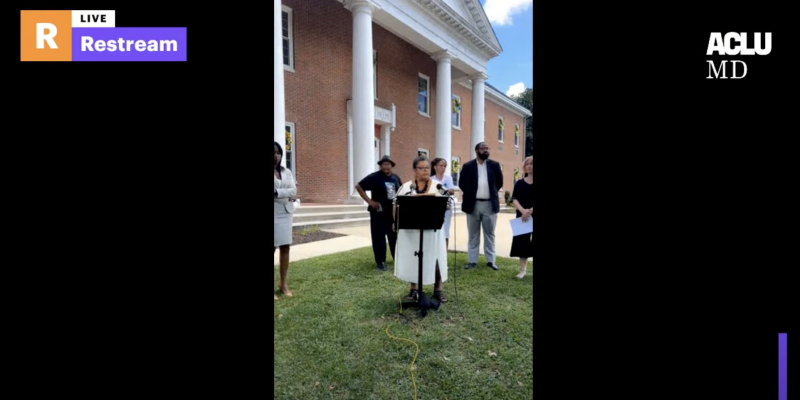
<box><xmin>396</xmin><ymin>195</ymin><xmax>450</xmax><ymax>317</ymax></box>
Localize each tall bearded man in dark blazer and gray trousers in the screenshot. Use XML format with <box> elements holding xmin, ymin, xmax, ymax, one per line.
<box><xmin>458</xmin><ymin>142</ymin><xmax>503</xmax><ymax>271</ymax></box>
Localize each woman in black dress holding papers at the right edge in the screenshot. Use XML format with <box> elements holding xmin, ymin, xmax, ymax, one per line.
<box><xmin>511</xmin><ymin>157</ymin><xmax>533</xmax><ymax>279</ymax></box>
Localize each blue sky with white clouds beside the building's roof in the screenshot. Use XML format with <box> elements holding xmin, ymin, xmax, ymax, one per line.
<box><xmin>481</xmin><ymin>0</ymin><xmax>533</xmax><ymax>95</ymax></box>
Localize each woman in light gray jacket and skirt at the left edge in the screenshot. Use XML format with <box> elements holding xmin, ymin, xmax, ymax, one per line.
<box><xmin>272</xmin><ymin>142</ymin><xmax>297</xmax><ymax>300</ymax></box>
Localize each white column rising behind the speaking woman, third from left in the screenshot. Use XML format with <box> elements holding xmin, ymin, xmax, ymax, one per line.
<box><xmin>433</xmin><ymin>50</ymin><xmax>453</xmax><ymax>175</ymax></box>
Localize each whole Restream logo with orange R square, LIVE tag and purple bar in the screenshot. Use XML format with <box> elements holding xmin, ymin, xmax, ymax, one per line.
<box><xmin>19</xmin><ymin>10</ymin><xmax>186</xmax><ymax>61</ymax></box>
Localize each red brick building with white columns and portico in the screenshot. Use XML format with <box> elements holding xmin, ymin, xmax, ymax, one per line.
<box><xmin>273</xmin><ymin>0</ymin><xmax>530</xmax><ymax>203</ymax></box>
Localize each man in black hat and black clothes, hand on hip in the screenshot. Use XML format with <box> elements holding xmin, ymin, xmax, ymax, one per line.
<box><xmin>356</xmin><ymin>156</ymin><xmax>403</xmax><ymax>271</ymax></box>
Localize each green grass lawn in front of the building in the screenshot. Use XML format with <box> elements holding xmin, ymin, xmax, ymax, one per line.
<box><xmin>273</xmin><ymin>248</ymin><xmax>533</xmax><ymax>400</ymax></box>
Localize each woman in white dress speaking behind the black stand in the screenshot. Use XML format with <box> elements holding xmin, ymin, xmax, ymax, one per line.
<box><xmin>393</xmin><ymin>157</ymin><xmax>450</xmax><ymax>303</ymax></box>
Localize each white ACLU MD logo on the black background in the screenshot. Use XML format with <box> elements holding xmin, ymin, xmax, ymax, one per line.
<box><xmin>706</xmin><ymin>32</ymin><xmax>772</xmax><ymax>79</ymax></box>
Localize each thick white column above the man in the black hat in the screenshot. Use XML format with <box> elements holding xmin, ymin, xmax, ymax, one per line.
<box><xmin>345</xmin><ymin>0</ymin><xmax>378</xmax><ymax>198</ymax></box>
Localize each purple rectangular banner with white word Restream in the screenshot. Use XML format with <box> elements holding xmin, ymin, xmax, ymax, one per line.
<box><xmin>72</xmin><ymin>28</ymin><xmax>186</xmax><ymax>61</ymax></box>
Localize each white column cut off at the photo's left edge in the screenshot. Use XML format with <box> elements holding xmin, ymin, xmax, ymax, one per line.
<box><xmin>272</xmin><ymin>0</ymin><xmax>286</xmax><ymax>166</ymax></box>
